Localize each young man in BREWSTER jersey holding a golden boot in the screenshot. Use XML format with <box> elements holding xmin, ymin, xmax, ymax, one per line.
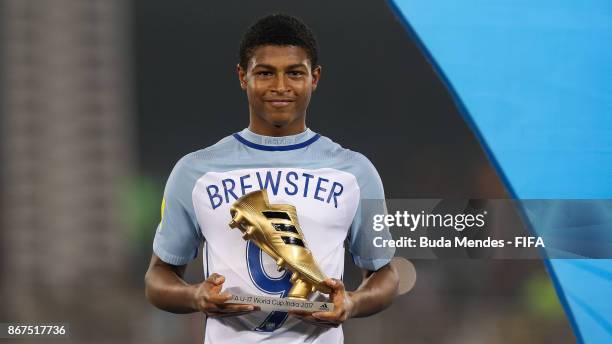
<box><xmin>145</xmin><ymin>15</ymin><xmax>398</xmax><ymax>344</ymax></box>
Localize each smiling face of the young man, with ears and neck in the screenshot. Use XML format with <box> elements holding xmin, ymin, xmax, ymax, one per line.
<box><xmin>238</xmin><ymin>45</ymin><xmax>321</xmax><ymax>135</ymax></box>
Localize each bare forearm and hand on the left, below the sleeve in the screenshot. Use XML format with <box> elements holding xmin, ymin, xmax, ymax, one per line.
<box><xmin>145</xmin><ymin>254</ymin><xmax>254</xmax><ymax>316</ymax></box>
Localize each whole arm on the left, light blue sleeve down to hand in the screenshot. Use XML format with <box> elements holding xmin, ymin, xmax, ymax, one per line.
<box><xmin>145</xmin><ymin>156</ymin><xmax>253</xmax><ymax>316</ymax></box>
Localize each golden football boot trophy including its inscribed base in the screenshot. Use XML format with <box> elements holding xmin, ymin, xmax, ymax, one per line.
<box><xmin>227</xmin><ymin>189</ymin><xmax>334</xmax><ymax>312</ymax></box>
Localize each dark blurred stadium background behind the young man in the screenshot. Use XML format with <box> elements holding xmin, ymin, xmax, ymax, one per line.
<box><xmin>0</xmin><ymin>0</ymin><xmax>575</xmax><ymax>343</ymax></box>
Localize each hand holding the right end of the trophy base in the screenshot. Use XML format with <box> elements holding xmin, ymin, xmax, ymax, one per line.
<box><xmin>289</xmin><ymin>278</ymin><xmax>354</xmax><ymax>327</ymax></box>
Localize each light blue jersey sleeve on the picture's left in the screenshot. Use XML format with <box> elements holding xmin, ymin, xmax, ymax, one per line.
<box><xmin>153</xmin><ymin>157</ymin><xmax>203</xmax><ymax>265</ymax></box>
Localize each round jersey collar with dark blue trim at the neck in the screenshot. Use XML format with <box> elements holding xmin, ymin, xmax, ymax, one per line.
<box><xmin>233</xmin><ymin>128</ymin><xmax>321</xmax><ymax>151</ymax></box>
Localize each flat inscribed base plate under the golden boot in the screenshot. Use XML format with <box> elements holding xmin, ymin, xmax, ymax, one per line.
<box><xmin>225</xmin><ymin>295</ymin><xmax>334</xmax><ymax>312</ymax></box>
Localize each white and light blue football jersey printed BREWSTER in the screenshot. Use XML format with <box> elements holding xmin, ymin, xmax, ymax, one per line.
<box><xmin>153</xmin><ymin>129</ymin><xmax>393</xmax><ymax>344</ymax></box>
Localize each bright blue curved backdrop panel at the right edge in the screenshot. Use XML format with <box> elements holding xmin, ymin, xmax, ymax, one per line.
<box><xmin>390</xmin><ymin>0</ymin><xmax>612</xmax><ymax>343</ymax></box>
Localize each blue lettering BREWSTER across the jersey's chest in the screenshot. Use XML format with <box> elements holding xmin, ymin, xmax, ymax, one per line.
<box><xmin>206</xmin><ymin>170</ymin><xmax>344</xmax><ymax>209</ymax></box>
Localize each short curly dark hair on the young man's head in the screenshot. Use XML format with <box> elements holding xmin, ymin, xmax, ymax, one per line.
<box><xmin>239</xmin><ymin>14</ymin><xmax>318</xmax><ymax>70</ymax></box>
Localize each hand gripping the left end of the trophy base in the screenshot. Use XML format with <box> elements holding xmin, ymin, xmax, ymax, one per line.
<box><xmin>194</xmin><ymin>273</ymin><xmax>258</xmax><ymax>317</ymax></box>
